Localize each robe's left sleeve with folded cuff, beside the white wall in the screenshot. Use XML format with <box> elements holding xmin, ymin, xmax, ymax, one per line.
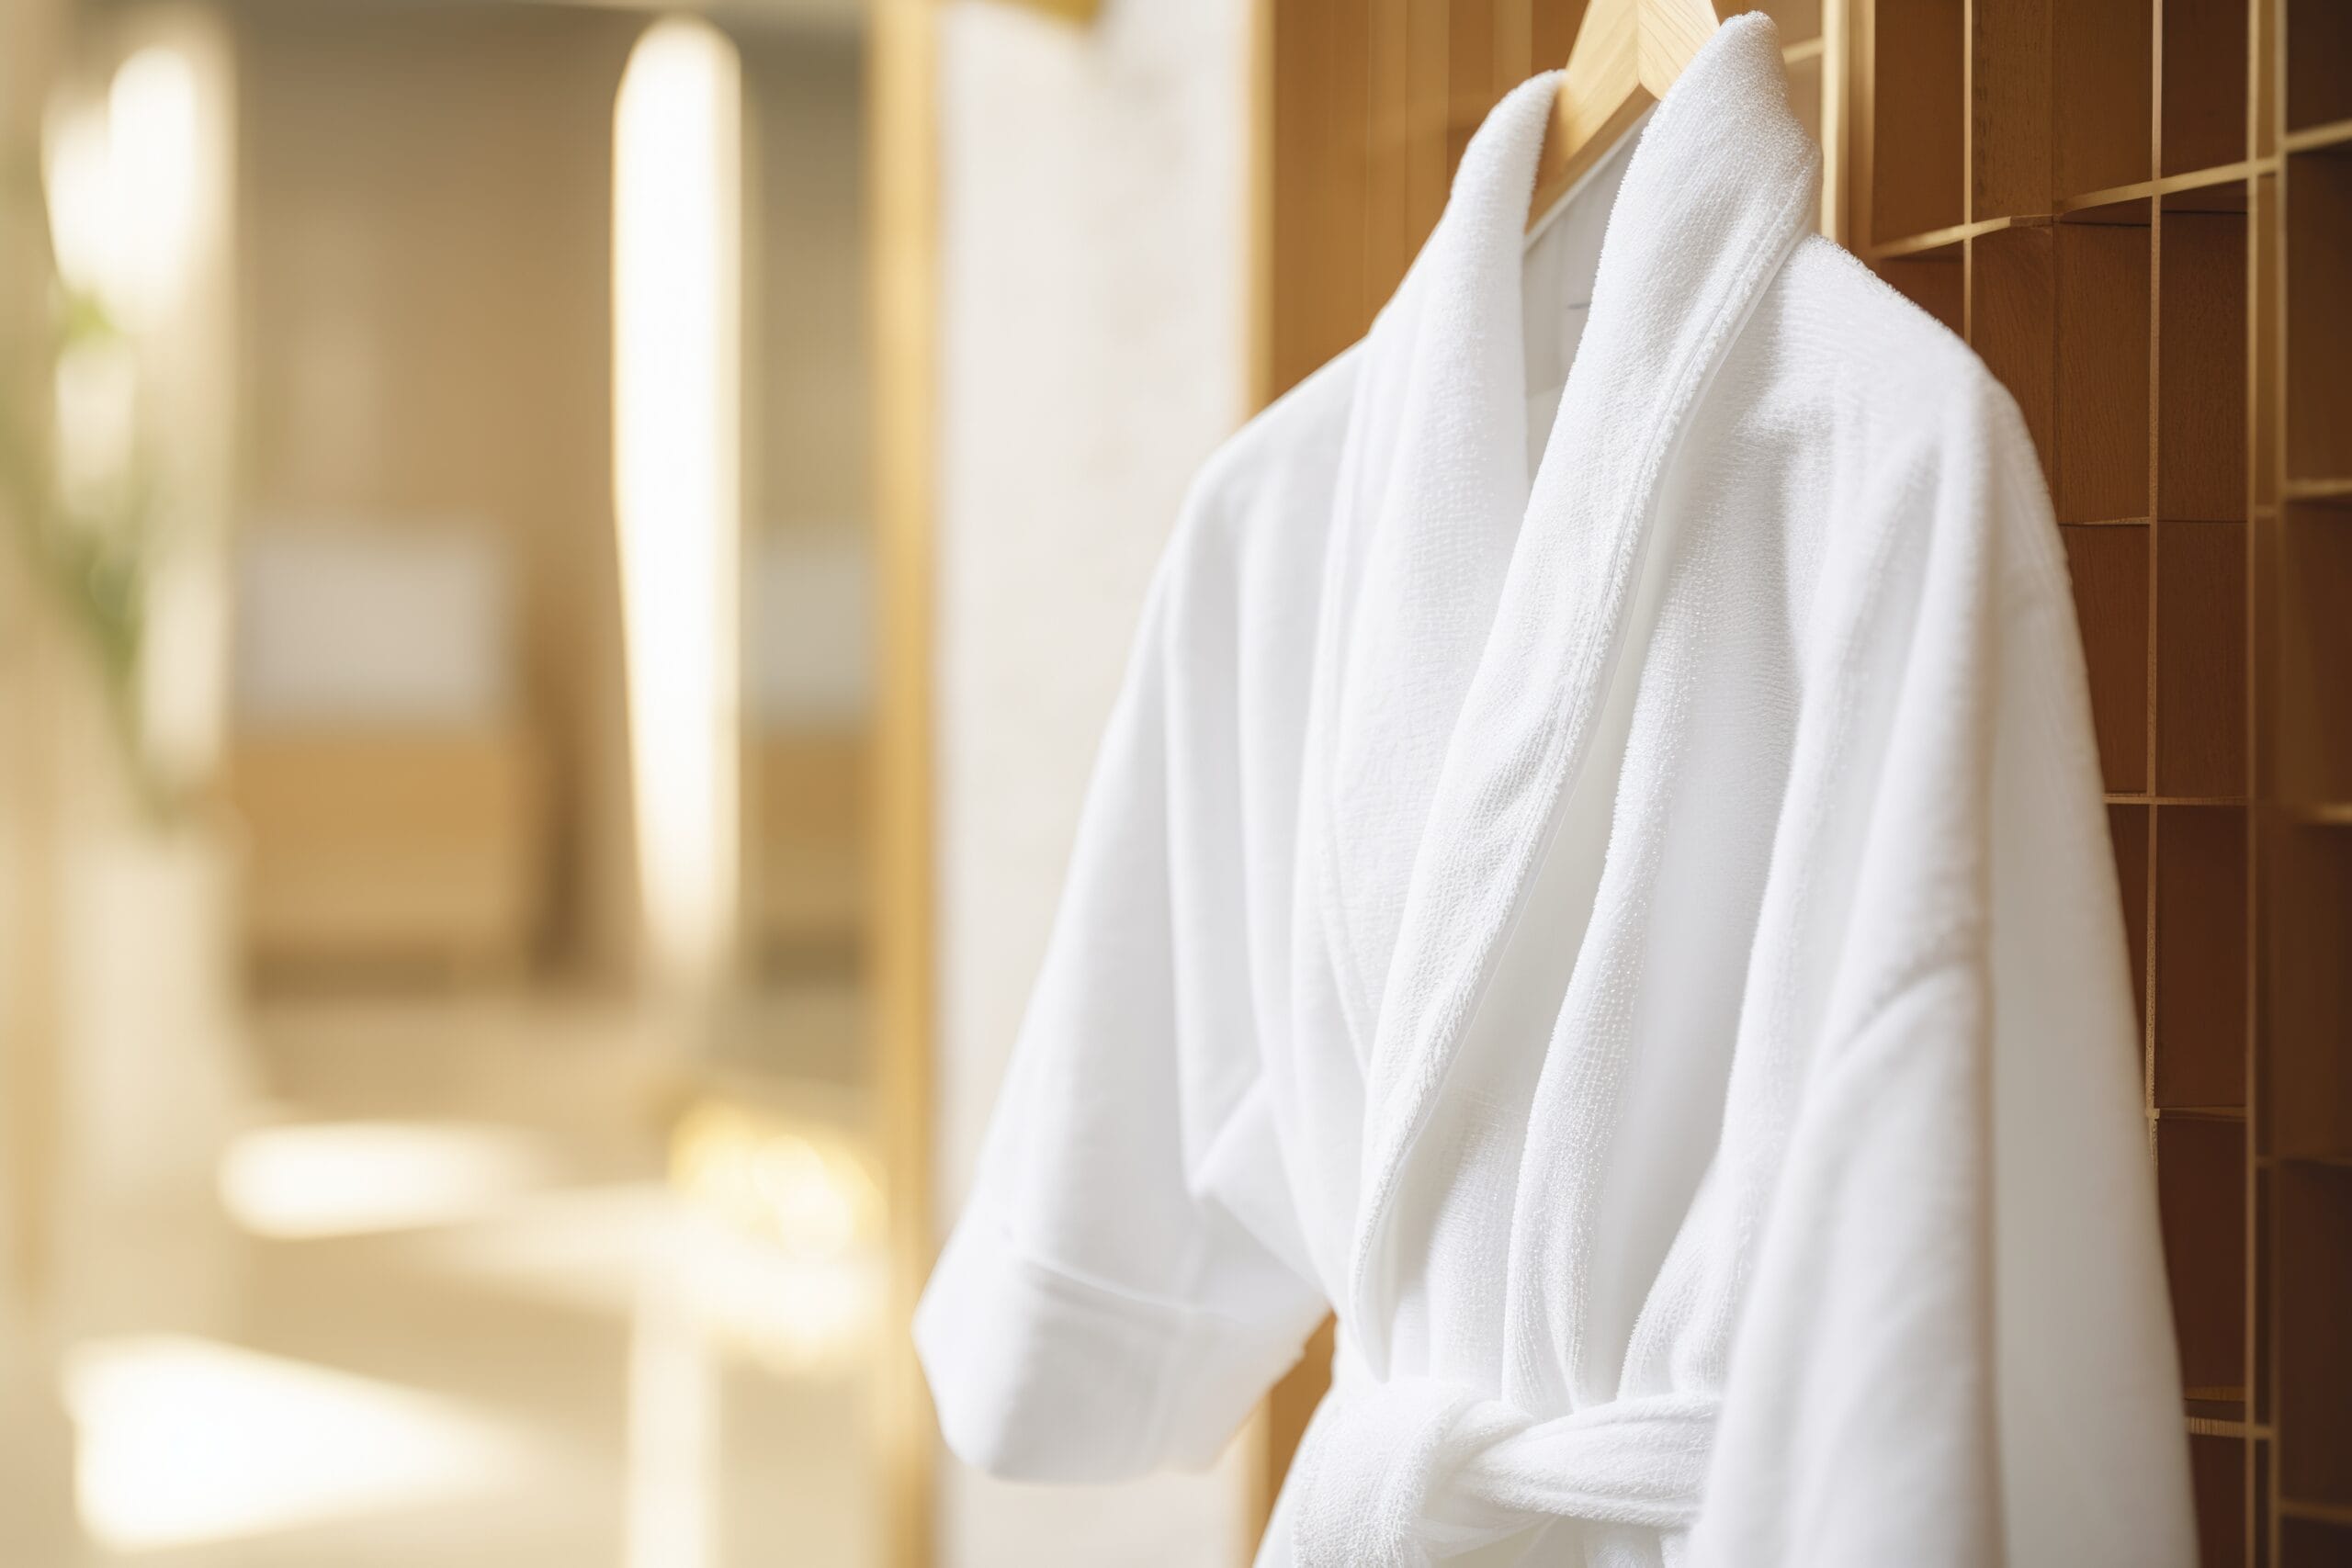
<box><xmin>915</xmin><ymin>479</ymin><xmax>1324</xmax><ymax>1481</ymax></box>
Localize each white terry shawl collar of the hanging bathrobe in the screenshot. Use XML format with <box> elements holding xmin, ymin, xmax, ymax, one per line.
<box><xmin>1303</xmin><ymin>17</ymin><xmax>1820</xmax><ymax>1371</ymax></box>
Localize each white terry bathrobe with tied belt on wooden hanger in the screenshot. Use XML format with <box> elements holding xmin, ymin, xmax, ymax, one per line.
<box><xmin>917</xmin><ymin>17</ymin><xmax>2192</xmax><ymax>1568</ymax></box>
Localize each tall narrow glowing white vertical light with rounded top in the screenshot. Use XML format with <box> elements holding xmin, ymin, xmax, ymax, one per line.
<box><xmin>614</xmin><ymin>18</ymin><xmax>743</xmax><ymax>995</ymax></box>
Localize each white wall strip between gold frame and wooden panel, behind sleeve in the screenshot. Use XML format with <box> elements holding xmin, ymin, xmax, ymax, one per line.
<box><xmin>938</xmin><ymin>0</ymin><xmax>1249</xmax><ymax>1568</ymax></box>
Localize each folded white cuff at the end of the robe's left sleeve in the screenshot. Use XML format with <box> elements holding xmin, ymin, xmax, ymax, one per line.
<box><xmin>915</xmin><ymin>1211</ymin><xmax>1301</xmax><ymax>1483</ymax></box>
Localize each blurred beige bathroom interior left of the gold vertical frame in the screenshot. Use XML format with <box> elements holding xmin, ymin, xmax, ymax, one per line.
<box><xmin>0</xmin><ymin>0</ymin><xmax>887</xmax><ymax>1565</ymax></box>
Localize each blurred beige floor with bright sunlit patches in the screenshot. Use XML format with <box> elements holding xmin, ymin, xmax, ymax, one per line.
<box><xmin>0</xmin><ymin>995</ymin><xmax>882</xmax><ymax>1568</ymax></box>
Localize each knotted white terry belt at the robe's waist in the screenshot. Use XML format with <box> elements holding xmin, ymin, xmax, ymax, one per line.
<box><xmin>1291</xmin><ymin>1378</ymin><xmax>1719</xmax><ymax>1568</ymax></box>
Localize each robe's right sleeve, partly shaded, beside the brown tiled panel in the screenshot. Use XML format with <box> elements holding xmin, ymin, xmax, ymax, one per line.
<box><xmin>1693</xmin><ymin>383</ymin><xmax>2194</xmax><ymax>1568</ymax></box>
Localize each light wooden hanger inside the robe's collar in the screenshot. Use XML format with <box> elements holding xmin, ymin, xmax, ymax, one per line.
<box><xmin>1526</xmin><ymin>0</ymin><xmax>1719</xmax><ymax>228</ymax></box>
